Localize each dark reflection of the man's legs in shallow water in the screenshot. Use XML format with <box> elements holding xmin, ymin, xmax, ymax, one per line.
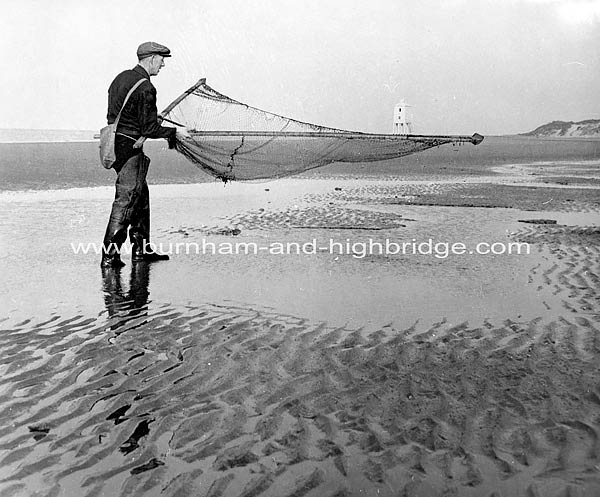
<box><xmin>102</xmin><ymin>262</ymin><xmax>150</xmax><ymax>331</ymax></box>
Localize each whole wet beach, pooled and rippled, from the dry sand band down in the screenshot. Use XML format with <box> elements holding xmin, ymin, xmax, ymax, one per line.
<box><xmin>0</xmin><ymin>163</ymin><xmax>600</xmax><ymax>497</ymax></box>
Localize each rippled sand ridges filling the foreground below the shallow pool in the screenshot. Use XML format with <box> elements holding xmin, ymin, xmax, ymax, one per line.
<box><xmin>0</xmin><ymin>294</ymin><xmax>600</xmax><ymax>495</ymax></box>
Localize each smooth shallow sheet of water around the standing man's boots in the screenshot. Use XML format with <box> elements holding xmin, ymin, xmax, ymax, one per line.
<box><xmin>0</xmin><ymin>181</ymin><xmax>568</xmax><ymax>328</ymax></box>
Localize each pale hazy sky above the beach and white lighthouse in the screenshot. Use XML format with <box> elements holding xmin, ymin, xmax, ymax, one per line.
<box><xmin>0</xmin><ymin>0</ymin><xmax>600</xmax><ymax>135</ymax></box>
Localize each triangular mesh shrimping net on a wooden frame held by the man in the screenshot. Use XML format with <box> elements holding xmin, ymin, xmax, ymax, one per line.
<box><xmin>161</xmin><ymin>79</ymin><xmax>483</xmax><ymax>181</ymax></box>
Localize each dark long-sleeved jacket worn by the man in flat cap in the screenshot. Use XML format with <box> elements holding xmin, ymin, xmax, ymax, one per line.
<box><xmin>106</xmin><ymin>65</ymin><xmax>176</xmax><ymax>162</ymax></box>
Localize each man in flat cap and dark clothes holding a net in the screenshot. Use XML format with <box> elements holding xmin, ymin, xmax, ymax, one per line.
<box><xmin>101</xmin><ymin>42</ymin><xmax>189</xmax><ymax>268</ymax></box>
